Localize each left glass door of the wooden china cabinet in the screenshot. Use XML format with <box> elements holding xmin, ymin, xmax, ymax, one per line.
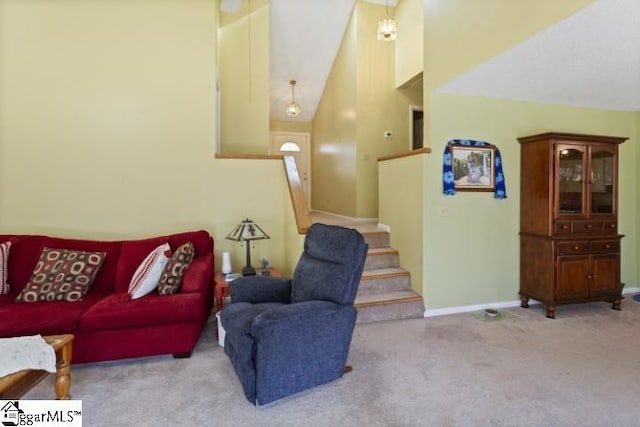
<box><xmin>557</xmin><ymin>145</ymin><xmax>586</xmax><ymax>215</ymax></box>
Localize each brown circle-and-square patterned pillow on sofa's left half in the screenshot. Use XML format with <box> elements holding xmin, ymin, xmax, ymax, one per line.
<box><xmin>16</xmin><ymin>248</ymin><xmax>107</xmax><ymax>302</ymax></box>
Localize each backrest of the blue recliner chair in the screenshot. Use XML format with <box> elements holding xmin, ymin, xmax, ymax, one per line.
<box><xmin>291</xmin><ymin>224</ymin><xmax>367</xmax><ymax>305</ymax></box>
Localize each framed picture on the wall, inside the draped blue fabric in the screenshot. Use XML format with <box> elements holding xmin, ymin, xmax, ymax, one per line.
<box><xmin>450</xmin><ymin>144</ymin><xmax>496</xmax><ymax>191</ymax></box>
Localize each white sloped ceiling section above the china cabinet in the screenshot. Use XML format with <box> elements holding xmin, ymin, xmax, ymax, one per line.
<box><xmin>438</xmin><ymin>0</ymin><xmax>640</xmax><ymax>111</ymax></box>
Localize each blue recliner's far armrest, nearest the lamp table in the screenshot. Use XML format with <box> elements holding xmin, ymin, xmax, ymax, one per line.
<box><xmin>229</xmin><ymin>276</ymin><xmax>291</xmax><ymax>304</ymax></box>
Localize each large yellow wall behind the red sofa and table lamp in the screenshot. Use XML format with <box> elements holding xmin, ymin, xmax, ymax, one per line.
<box><xmin>0</xmin><ymin>0</ymin><xmax>296</xmax><ymax>274</ymax></box>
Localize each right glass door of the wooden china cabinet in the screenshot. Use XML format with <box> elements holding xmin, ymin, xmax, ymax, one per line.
<box><xmin>589</xmin><ymin>146</ymin><xmax>615</xmax><ymax>215</ymax></box>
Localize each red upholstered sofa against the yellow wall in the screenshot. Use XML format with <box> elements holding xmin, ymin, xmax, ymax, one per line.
<box><xmin>0</xmin><ymin>230</ymin><xmax>214</xmax><ymax>363</ymax></box>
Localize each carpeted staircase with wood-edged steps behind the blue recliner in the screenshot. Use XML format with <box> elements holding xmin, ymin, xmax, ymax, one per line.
<box><xmin>355</xmin><ymin>231</ymin><xmax>424</xmax><ymax>323</ymax></box>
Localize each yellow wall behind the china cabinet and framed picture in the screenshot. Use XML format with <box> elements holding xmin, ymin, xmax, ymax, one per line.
<box><xmin>423</xmin><ymin>94</ymin><xmax>640</xmax><ymax>309</ymax></box>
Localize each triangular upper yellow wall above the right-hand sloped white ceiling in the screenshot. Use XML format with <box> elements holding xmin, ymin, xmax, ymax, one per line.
<box><xmin>424</xmin><ymin>0</ymin><xmax>595</xmax><ymax>145</ymax></box>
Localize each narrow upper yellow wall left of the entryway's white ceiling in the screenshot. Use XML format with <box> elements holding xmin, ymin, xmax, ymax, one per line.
<box><xmin>215</xmin><ymin>0</ymin><xmax>269</xmax><ymax>154</ymax></box>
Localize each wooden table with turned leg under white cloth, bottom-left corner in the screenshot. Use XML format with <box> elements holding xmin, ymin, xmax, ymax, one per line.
<box><xmin>0</xmin><ymin>334</ymin><xmax>73</xmax><ymax>400</ymax></box>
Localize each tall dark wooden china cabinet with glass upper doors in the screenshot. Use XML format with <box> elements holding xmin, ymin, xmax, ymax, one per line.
<box><xmin>518</xmin><ymin>132</ymin><xmax>627</xmax><ymax>318</ymax></box>
